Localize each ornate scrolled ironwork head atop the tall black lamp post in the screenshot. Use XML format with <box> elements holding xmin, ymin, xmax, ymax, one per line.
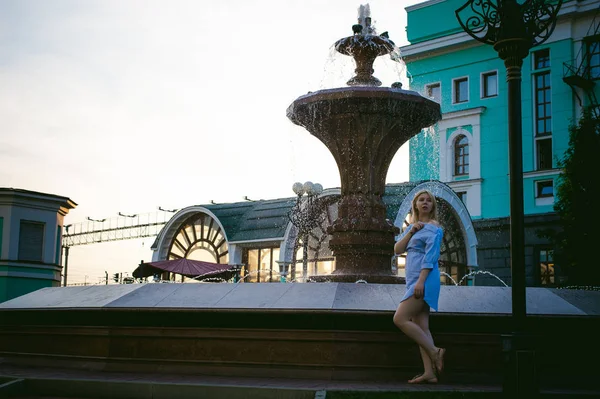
<box><xmin>456</xmin><ymin>0</ymin><xmax>563</xmax><ymax>47</ymax></box>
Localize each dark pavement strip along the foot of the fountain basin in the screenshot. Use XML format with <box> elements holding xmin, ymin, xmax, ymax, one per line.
<box><xmin>0</xmin><ymin>363</ymin><xmax>600</xmax><ymax>399</ymax></box>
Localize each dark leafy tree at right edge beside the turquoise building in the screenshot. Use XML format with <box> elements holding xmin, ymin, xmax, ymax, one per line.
<box><xmin>552</xmin><ymin>109</ymin><xmax>600</xmax><ymax>286</ymax></box>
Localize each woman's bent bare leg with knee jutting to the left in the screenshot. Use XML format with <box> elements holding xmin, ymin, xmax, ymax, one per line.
<box><xmin>394</xmin><ymin>296</ymin><xmax>440</xmax><ymax>359</ymax></box>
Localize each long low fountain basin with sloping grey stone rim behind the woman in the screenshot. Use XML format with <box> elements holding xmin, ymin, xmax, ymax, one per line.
<box><xmin>0</xmin><ymin>283</ymin><xmax>600</xmax><ymax>390</ymax></box>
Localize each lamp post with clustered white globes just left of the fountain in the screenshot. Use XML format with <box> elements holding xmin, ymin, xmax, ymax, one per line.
<box><xmin>288</xmin><ymin>181</ymin><xmax>323</xmax><ymax>281</ymax></box>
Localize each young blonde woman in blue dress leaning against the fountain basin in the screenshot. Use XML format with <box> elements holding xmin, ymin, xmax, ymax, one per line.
<box><xmin>394</xmin><ymin>190</ymin><xmax>446</xmax><ymax>384</ymax></box>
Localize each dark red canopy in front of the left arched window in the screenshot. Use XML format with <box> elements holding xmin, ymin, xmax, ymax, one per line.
<box><xmin>133</xmin><ymin>258</ymin><xmax>232</xmax><ymax>278</ymax></box>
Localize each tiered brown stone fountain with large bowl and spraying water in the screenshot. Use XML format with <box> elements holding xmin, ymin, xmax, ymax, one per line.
<box><xmin>287</xmin><ymin>6</ymin><xmax>441</xmax><ymax>283</ymax></box>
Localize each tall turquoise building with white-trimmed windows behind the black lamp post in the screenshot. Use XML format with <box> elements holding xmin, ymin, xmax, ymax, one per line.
<box><xmin>401</xmin><ymin>0</ymin><xmax>600</xmax><ymax>285</ymax></box>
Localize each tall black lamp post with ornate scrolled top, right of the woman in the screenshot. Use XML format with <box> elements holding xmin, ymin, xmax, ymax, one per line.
<box><xmin>456</xmin><ymin>0</ymin><xmax>562</xmax><ymax>397</ymax></box>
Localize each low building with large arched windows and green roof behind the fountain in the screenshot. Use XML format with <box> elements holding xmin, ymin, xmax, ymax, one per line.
<box><xmin>152</xmin><ymin>180</ymin><xmax>478</xmax><ymax>285</ymax></box>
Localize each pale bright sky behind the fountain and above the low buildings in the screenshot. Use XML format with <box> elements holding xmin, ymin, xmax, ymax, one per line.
<box><xmin>0</xmin><ymin>0</ymin><xmax>421</xmax><ymax>283</ymax></box>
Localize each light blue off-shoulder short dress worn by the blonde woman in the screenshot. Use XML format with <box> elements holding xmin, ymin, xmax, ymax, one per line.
<box><xmin>400</xmin><ymin>223</ymin><xmax>444</xmax><ymax>311</ymax></box>
